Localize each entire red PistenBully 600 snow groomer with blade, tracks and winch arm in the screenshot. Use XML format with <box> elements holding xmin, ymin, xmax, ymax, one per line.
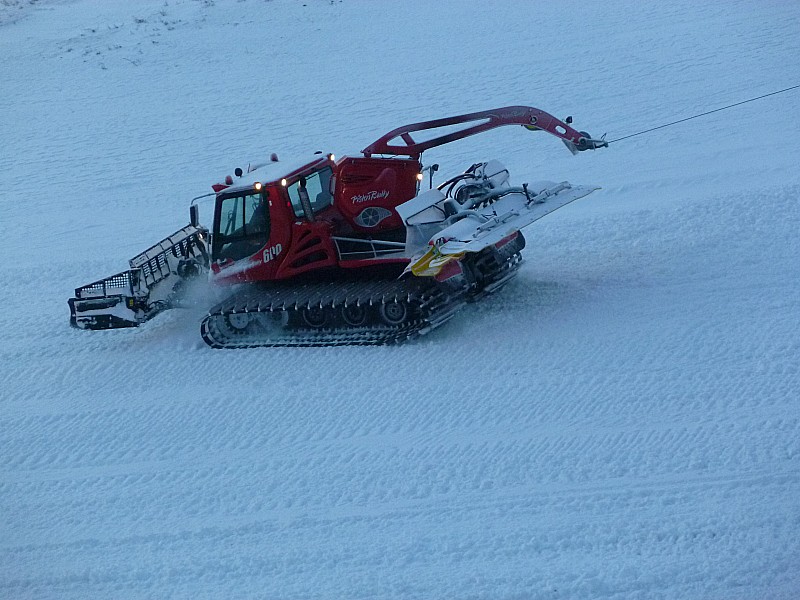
<box><xmin>70</xmin><ymin>106</ymin><xmax>605</xmax><ymax>348</ymax></box>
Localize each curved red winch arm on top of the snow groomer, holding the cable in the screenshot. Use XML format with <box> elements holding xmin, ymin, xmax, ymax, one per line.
<box><xmin>362</xmin><ymin>106</ymin><xmax>608</xmax><ymax>159</ymax></box>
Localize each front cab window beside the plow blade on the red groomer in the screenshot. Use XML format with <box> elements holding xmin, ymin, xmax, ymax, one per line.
<box><xmin>212</xmin><ymin>193</ymin><xmax>269</xmax><ymax>260</ymax></box>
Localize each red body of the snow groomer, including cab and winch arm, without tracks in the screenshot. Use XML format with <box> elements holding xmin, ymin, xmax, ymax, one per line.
<box><xmin>206</xmin><ymin>106</ymin><xmax>592</xmax><ymax>283</ymax></box>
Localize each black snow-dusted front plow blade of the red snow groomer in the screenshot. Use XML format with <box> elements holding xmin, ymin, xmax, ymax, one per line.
<box><xmin>68</xmin><ymin>225</ymin><xmax>209</xmax><ymax>330</ymax></box>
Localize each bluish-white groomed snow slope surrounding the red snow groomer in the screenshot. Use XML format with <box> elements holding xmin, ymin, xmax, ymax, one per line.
<box><xmin>0</xmin><ymin>0</ymin><xmax>800</xmax><ymax>599</ymax></box>
